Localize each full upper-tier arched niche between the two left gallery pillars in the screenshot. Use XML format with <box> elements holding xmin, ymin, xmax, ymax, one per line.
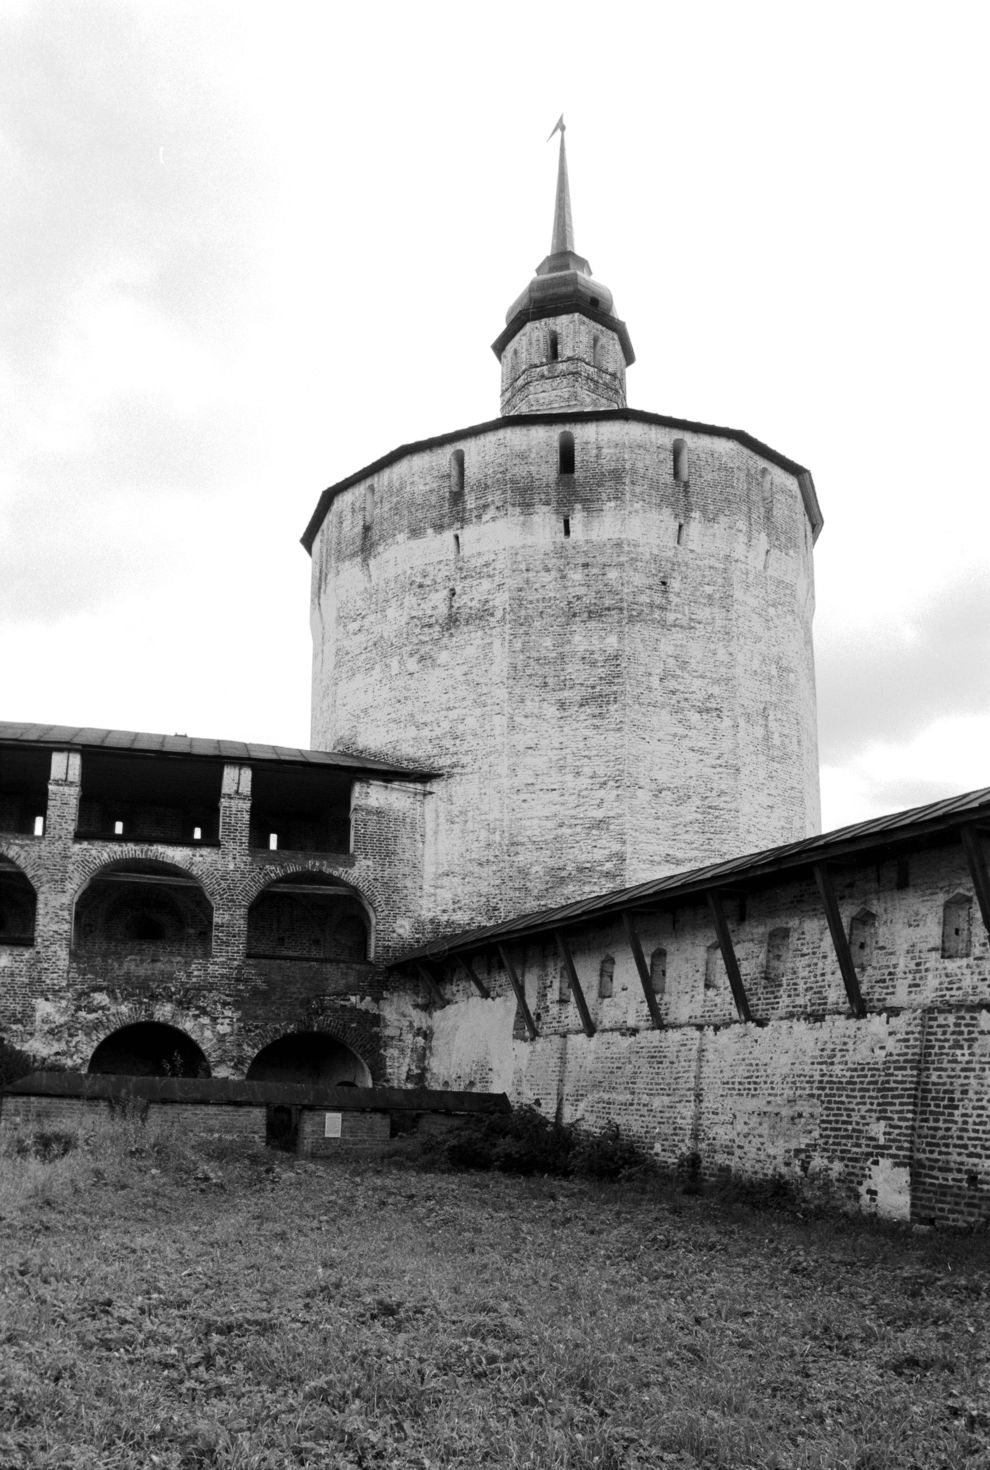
<box><xmin>74</xmin><ymin>860</ymin><xmax>213</xmax><ymax>957</ymax></box>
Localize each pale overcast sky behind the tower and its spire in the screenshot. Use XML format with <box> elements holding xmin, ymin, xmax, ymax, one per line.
<box><xmin>0</xmin><ymin>0</ymin><xmax>990</xmax><ymax>828</ymax></box>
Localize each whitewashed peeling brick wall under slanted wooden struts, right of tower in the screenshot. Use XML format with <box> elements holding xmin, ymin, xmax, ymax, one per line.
<box><xmin>385</xmin><ymin>847</ymin><xmax>990</xmax><ymax>1225</ymax></box>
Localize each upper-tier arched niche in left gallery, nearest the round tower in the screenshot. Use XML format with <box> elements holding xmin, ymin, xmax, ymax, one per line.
<box><xmin>247</xmin><ymin>873</ymin><xmax>371</xmax><ymax>963</ymax></box>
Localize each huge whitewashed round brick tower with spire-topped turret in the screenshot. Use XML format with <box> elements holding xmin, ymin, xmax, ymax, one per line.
<box><xmin>303</xmin><ymin>126</ymin><xmax>821</xmax><ymax>932</ymax></box>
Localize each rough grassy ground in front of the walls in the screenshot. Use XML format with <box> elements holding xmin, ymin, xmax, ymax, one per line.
<box><xmin>0</xmin><ymin>1125</ymin><xmax>990</xmax><ymax>1470</ymax></box>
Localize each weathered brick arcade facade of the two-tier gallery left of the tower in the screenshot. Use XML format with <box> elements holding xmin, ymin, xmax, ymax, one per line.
<box><xmin>0</xmin><ymin>751</ymin><xmax>425</xmax><ymax>1080</ymax></box>
